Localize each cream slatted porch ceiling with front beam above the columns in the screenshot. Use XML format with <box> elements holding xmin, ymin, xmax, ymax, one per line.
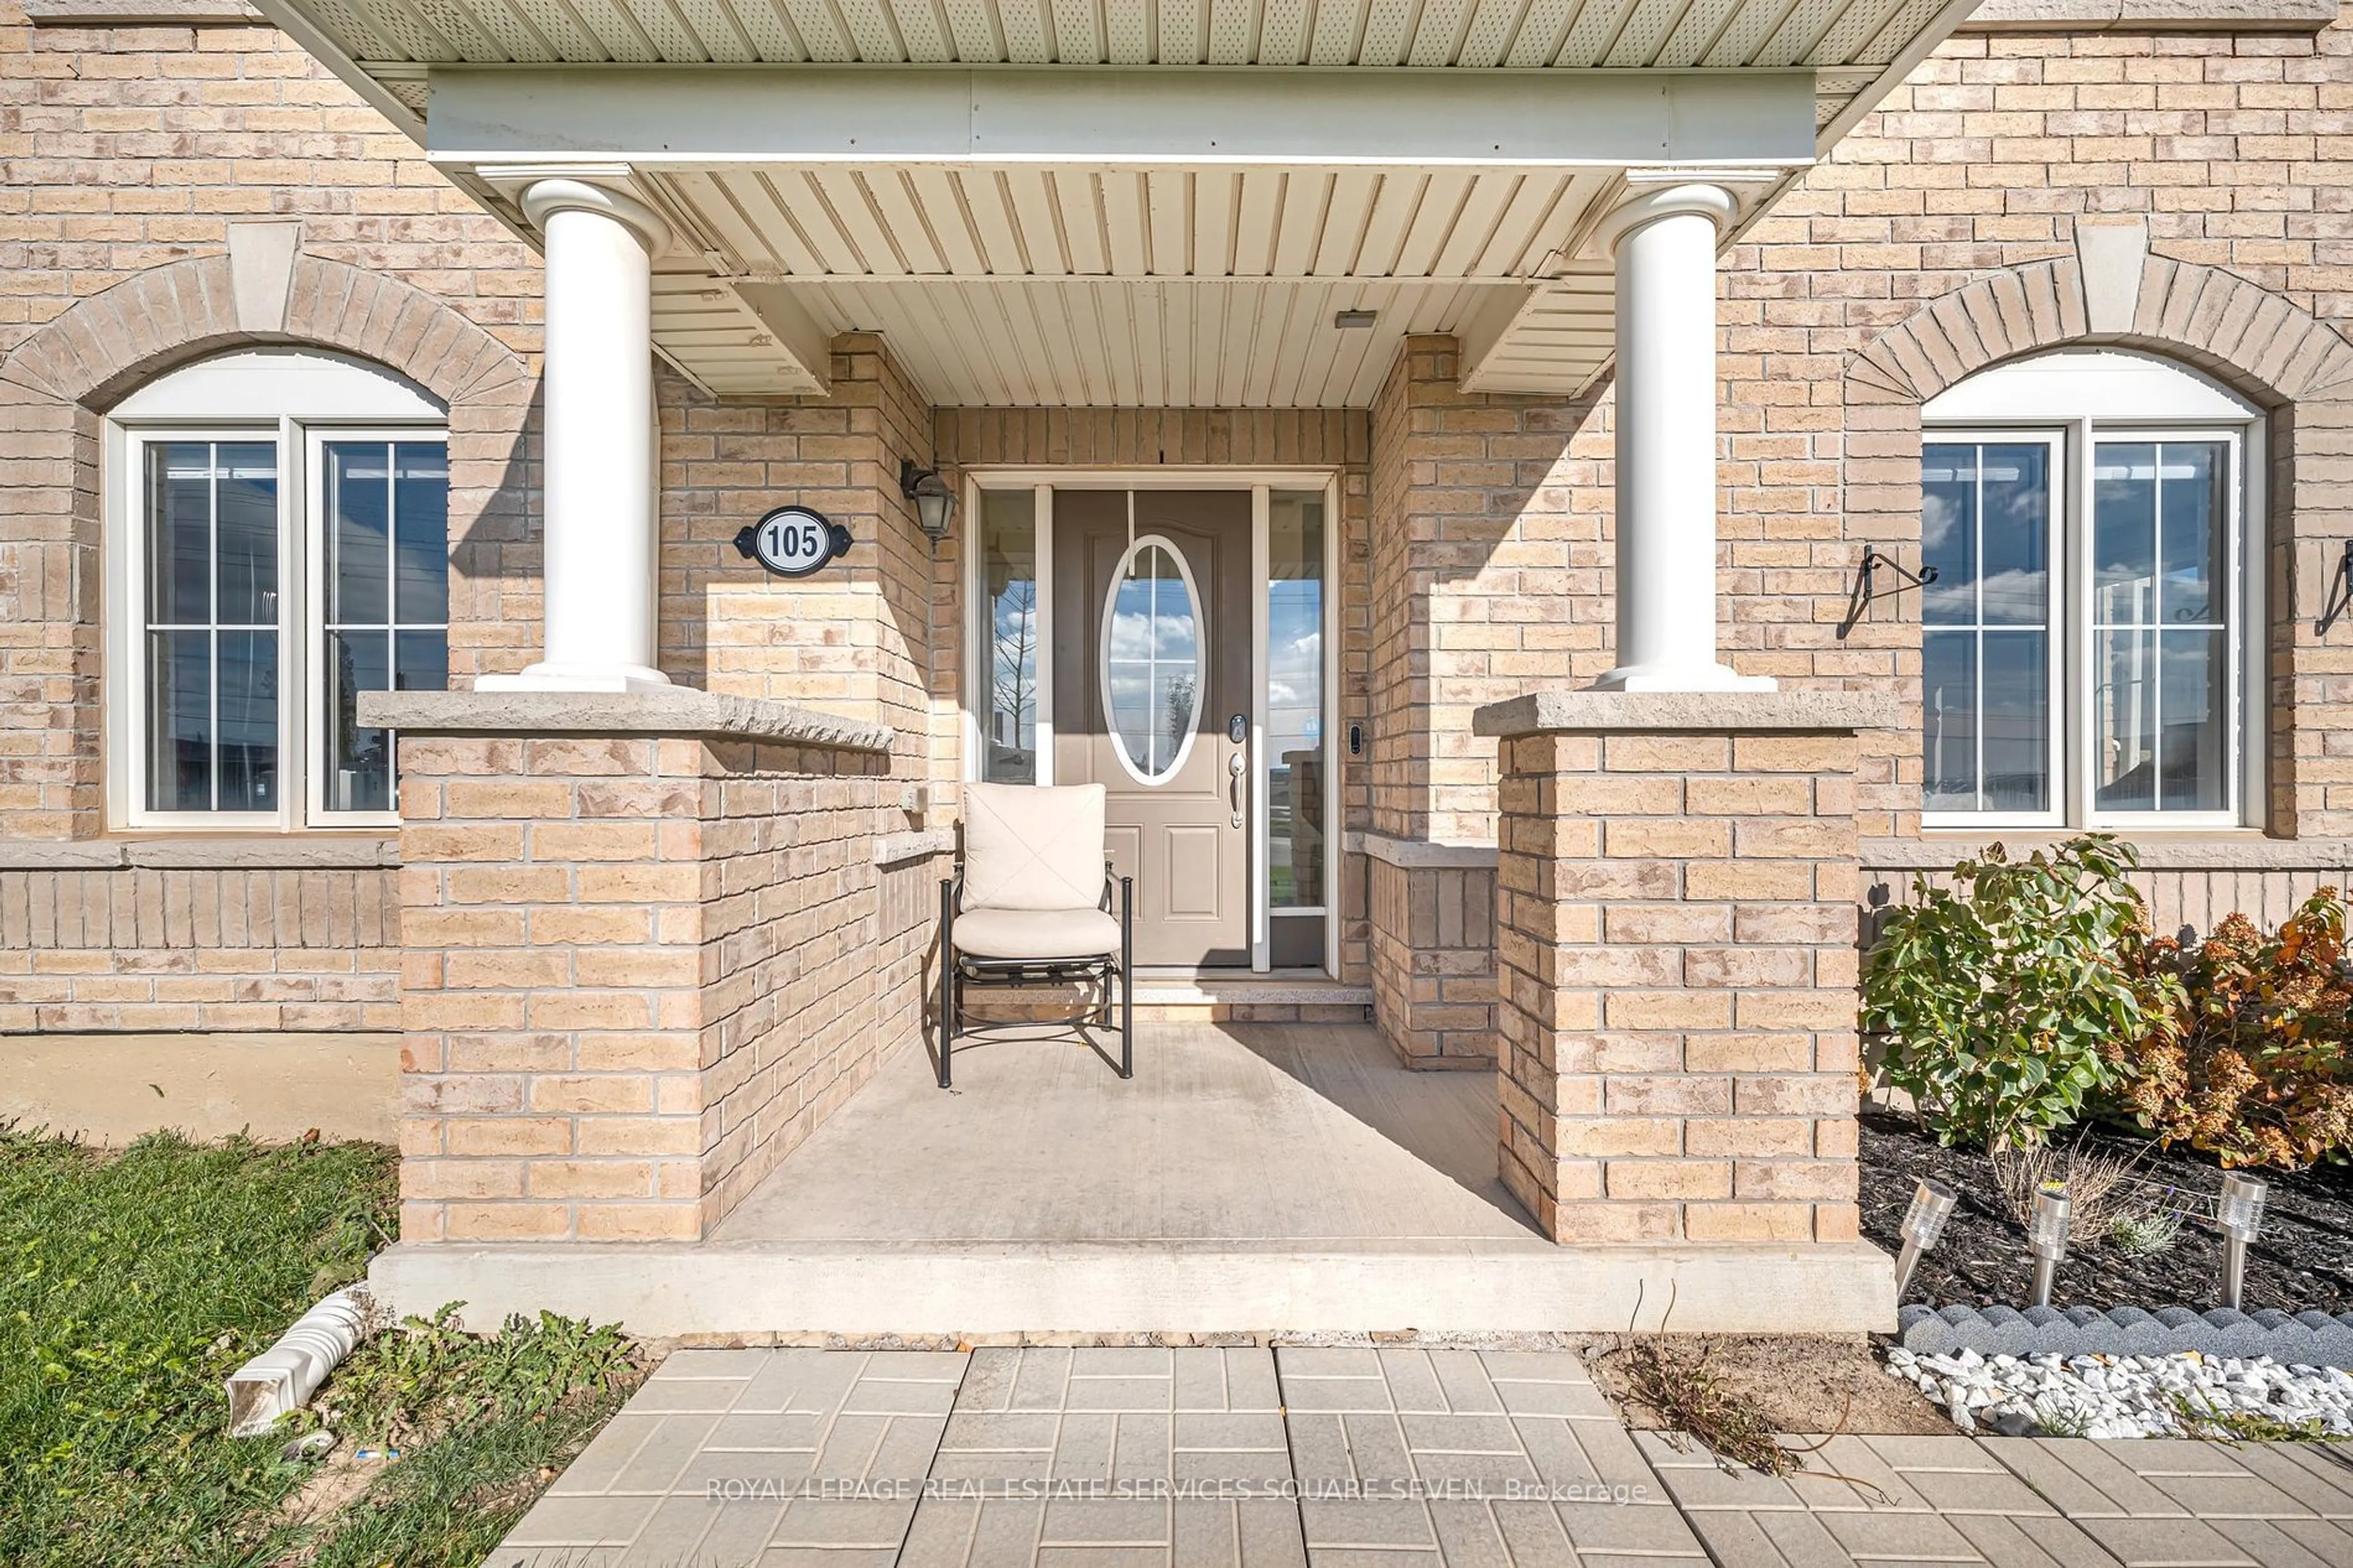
<box><xmin>257</xmin><ymin>0</ymin><xmax>1974</xmax><ymax>407</ymax></box>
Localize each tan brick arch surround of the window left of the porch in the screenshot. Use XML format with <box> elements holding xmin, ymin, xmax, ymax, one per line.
<box><xmin>0</xmin><ymin>254</ymin><xmax>539</xmax><ymax>838</ymax></box>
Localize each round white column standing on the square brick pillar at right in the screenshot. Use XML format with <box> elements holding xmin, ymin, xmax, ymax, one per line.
<box><xmin>1596</xmin><ymin>184</ymin><xmax>1774</xmax><ymax>692</ymax></box>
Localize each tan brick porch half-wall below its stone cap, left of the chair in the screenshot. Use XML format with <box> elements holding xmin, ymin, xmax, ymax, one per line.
<box><xmin>400</xmin><ymin>735</ymin><xmax>927</xmax><ymax>1241</ymax></box>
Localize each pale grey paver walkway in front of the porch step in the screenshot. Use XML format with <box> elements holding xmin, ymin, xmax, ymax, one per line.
<box><xmin>490</xmin><ymin>1347</ymin><xmax>2353</xmax><ymax>1568</ymax></box>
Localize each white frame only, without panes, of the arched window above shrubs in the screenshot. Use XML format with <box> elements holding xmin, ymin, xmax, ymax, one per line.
<box><xmin>1920</xmin><ymin>353</ymin><xmax>2268</xmax><ymax>833</ymax></box>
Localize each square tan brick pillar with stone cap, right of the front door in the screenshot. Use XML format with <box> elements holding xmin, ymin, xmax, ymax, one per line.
<box><xmin>1478</xmin><ymin>692</ymin><xmax>1894</xmax><ymax>1243</ymax></box>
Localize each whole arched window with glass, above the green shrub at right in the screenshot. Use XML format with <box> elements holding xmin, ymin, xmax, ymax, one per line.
<box><xmin>1920</xmin><ymin>351</ymin><xmax>2264</xmax><ymax>827</ymax></box>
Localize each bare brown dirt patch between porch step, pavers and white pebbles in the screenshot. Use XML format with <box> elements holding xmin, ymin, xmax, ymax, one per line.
<box><xmin>1577</xmin><ymin>1335</ymin><xmax>1953</xmax><ymax>1434</ymax></box>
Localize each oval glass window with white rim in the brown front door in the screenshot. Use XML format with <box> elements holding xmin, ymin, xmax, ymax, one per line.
<box><xmin>1104</xmin><ymin>534</ymin><xmax>1202</xmax><ymax>784</ymax></box>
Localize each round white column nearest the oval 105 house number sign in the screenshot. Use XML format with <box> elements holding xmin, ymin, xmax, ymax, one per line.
<box><xmin>476</xmin><ymin>179</ymin><xmax>670</xmax><ymax>692</ymax></box>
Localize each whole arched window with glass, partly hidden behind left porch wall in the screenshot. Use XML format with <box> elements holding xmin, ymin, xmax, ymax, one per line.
<box><xmin>106</xmin><ymin>349</ymin><xmax>449</xmax><ymax>829</ymax></box>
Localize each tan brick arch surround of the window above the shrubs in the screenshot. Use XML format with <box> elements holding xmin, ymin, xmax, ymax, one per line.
<box><xmin>1845</xmin><ymin>254</ymin><xmax>2353</xmax><ymax>838</ymax></box>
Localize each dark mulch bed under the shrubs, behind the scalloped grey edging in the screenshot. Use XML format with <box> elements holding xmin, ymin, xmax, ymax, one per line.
<box><xmin>1861</xmin><ymin>1112</ymin><xmax>2353</xmax><ymax>1311</ymax></box>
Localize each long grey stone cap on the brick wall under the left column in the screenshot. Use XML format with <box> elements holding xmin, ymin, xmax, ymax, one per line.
<box><xmin>360</xmin><ymin>685</ymin><xmax>894</xmax><ymax>751</ymax></box>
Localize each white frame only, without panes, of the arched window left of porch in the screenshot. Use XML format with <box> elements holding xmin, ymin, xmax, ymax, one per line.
<box><xmin>101</xmin><ymin>351</ymin><xmax>449</xmax><ymax>833</ymax></box>
